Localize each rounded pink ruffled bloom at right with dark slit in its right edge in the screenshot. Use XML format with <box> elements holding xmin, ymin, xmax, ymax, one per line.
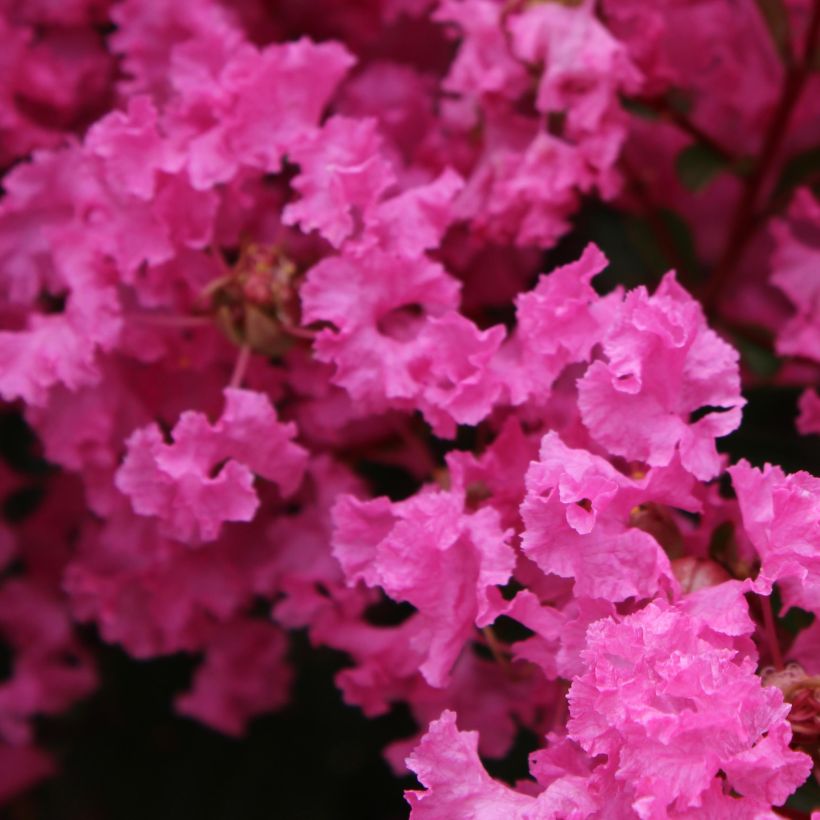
<box><xmin>578</xmin><ymin>274</ymin><xmax>744</xmax><ymax>480</ymax></box>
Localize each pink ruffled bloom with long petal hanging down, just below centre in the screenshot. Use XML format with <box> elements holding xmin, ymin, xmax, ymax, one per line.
<box><xmin>333</xmin><ymin>490</ymin><xmax>515</xmax><ymax>686</ymax></box>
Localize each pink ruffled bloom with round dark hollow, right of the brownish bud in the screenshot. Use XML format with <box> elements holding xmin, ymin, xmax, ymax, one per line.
<box><xmin>301</xmin><ymin>251</ymin><xmax>504</xmax><ymax>436</ymax></box>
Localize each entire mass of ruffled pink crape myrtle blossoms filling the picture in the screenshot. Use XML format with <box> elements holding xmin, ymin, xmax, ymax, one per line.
<box><xmin>0</xmin><ymin>0</ymin><xmax>820</xmax><ymax>820</ymax></box>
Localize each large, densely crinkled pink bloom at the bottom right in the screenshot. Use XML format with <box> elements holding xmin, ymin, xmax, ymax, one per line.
<box><xmin>568</xmin><ymin>601</ymin><xmax>811</xmax><ymax>817</ymax></box>
